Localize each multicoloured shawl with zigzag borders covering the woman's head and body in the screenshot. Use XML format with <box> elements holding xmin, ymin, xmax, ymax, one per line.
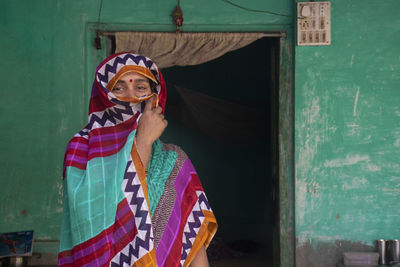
<box><xmin>58</xmin><ymin>53</ymin><xmax>217</xmax><ymax>267</ymax></box>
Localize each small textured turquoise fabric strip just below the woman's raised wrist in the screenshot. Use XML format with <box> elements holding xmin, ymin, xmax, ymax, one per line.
<box><xmin>146</xmin><ymin>139</ymin><xmax>178</xmax><ymax>216</ymax></box>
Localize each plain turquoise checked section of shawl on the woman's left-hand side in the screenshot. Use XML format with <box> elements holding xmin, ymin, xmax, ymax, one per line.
<box><xmin>60</xmin><ymin>131</ymin><xmax>135</xmax><ymax>251</ymax></box>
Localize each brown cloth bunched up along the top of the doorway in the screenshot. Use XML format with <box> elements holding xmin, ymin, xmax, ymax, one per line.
<box><xmin>115</xmin><ymin>32</ymin><xmax>267</xmax><ymax>68</ymax></box>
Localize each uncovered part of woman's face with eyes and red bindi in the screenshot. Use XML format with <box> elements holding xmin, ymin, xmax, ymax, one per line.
<box><xmin>111</xmin><ymin>72</ymin><xmax>151</xmax><ymax>98</ymax></box>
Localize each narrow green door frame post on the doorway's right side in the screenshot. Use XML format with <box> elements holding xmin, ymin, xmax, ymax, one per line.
<box><xmin>278</xmin><ymin>32</ymin><xmax>295</xmax><ymax>267</ymax></box>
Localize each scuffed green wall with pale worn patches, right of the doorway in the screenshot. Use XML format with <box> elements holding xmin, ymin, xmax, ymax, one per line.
<box><xmin>295</xmin><ymin>0</ymin><xmax>400</xmax><ymax>266</ymax></box>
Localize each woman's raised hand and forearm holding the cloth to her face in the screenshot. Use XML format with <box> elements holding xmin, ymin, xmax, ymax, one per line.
<box><xmin>136</xmin><ymin>98</ymin><xmax>168</xmax><ymax>170</ymax></box>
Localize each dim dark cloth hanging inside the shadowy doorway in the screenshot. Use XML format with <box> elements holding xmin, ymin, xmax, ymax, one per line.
<box><xmin>168</xmin><ymin>83</ymin><xmax>266</xmax><ymax>145</ymax></box>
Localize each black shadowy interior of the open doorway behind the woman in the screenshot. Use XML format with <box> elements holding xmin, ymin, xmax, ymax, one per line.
<box><xmin>162</xmin><ymin>38</ymin><xmax>279</xmax><ymax>267</ymax></box>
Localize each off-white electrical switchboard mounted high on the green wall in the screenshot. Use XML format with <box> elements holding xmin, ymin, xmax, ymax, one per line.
<box><xmin>297</xmin><ymin>2</ymin><xmax>331</xmax><ymax>46</ymax></box>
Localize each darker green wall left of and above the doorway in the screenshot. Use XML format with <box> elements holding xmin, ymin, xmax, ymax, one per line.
<box><xmin>0</xmin><ymin>0</ymin><xmax>293</xmax><ymax>262</ymax></box>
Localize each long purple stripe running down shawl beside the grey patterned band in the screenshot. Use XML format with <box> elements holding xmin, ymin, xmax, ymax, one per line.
<box><xmin>156</xmin><ymin>159</ymin><xmax>195</xmax><ymax>266</ymax></box>
